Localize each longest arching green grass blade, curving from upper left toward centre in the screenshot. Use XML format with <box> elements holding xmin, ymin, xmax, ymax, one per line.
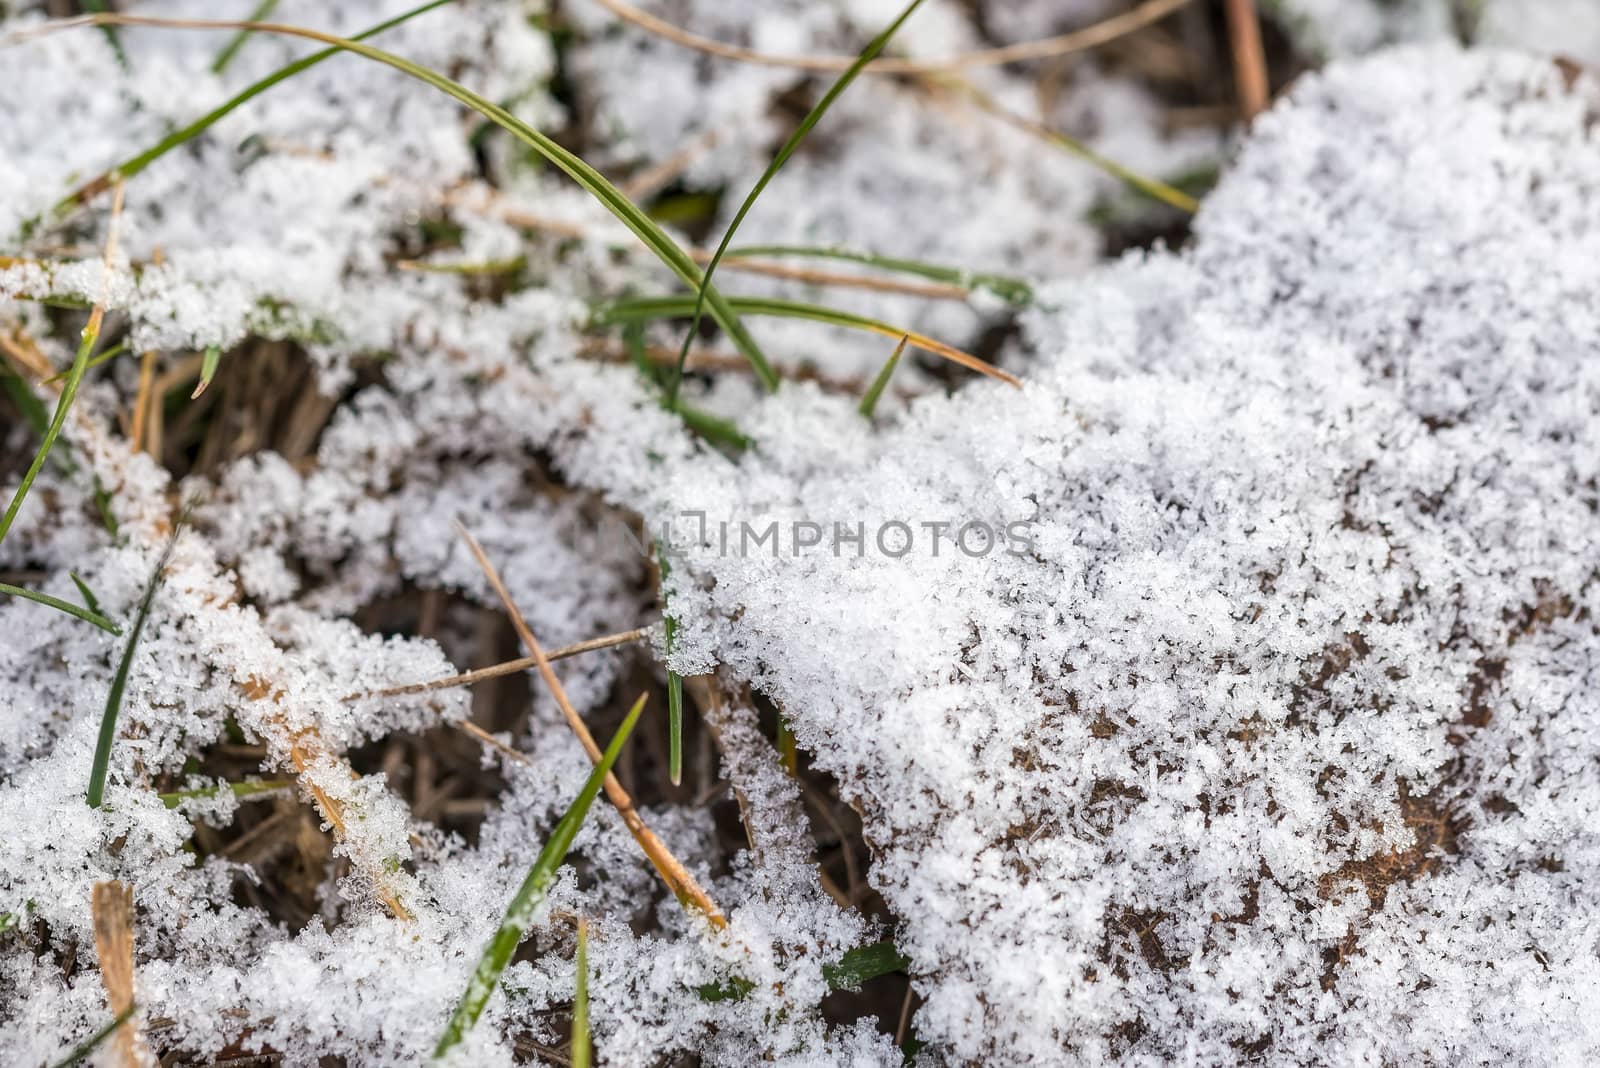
<box><xmin>54</xmin><ymin>8</ymin><xmax>780</xmax><ymax>390</ymax></box>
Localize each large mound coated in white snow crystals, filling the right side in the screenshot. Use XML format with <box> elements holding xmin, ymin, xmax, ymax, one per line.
<box><xmin>620</xmin><ymin>50</ymin><xmax>1600</xmax><ymax>1065</ymax></box>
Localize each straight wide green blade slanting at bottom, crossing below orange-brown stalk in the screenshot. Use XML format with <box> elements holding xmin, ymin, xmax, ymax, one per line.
<box><xmin>434</xmin><ymin>697</ymin><xmax>645</xmax><ymax>1058</ymax></box>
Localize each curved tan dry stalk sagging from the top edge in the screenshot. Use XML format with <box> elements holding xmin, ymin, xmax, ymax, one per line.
<box><xmin>585</xmin><ymin>0</ymin><xmax>1189</xmax><ymax>74</ymax></box>
